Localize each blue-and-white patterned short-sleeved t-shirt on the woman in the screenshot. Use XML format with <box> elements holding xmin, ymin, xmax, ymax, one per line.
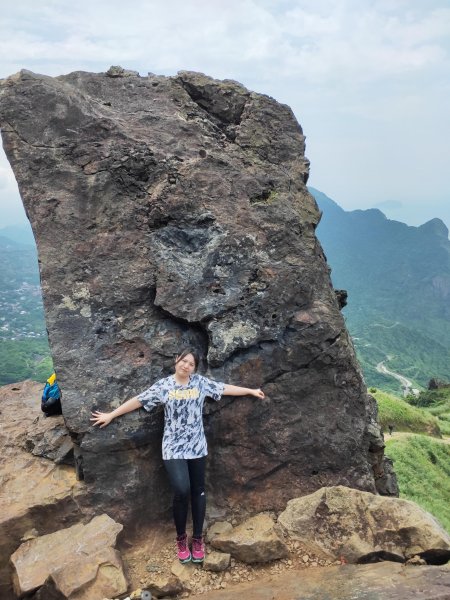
<box><xmin>136</xmin><ymin>373</ymin><xmax>225</xmax><ymax>460</ymax></box>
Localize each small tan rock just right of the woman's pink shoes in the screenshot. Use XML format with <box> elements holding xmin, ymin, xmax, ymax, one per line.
<box><xmin>211</xmin><ymin>514</ymin><xmax>289</xmax><ymax>564</ymax></box>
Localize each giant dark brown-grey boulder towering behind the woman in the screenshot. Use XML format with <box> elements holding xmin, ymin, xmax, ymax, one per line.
<box><xmin>0</xmin><ymin>64</ymin><xmax>395</xmax><ymax>522</ymax></box>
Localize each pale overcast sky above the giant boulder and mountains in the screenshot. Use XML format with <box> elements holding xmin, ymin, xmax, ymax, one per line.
<box><xmin>0</xmin><ymin>0</ymin><xmax>450</xmax><ymax>227</ymax></box>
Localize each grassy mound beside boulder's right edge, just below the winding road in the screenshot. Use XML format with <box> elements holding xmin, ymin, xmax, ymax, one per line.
<box><xmin>372</xmin><ymin>391</ymin><xmax>441</xmax><ymax>436</ymax></box>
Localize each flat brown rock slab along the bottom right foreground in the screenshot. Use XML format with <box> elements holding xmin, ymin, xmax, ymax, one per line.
<box><xmin>186</xmin><ymin>562</ymin><xmax>450</xmax><ymax>600</ymax></box>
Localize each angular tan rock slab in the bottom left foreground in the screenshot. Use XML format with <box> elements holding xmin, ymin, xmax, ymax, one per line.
<box><xmin>11</xmin><ymin>515</ymin><xmax>127</xmax><ymax>600</ymax></box>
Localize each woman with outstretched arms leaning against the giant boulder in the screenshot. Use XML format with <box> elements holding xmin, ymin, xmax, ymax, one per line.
<box><xmin>91</xmin><ymin>348</ymin><xmax>264</xmax><ymax>563</ymax></box>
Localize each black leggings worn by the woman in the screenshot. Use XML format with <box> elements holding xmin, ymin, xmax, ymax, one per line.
<box><xmin>163</xmin><ymin>456</ymin><xmax>206</xmax><ymax>537</ymax></box>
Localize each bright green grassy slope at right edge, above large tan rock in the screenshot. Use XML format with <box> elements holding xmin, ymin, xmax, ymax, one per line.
<box><xmin>386</xmin><ymin>434</ymin><xmax>450</xmax><ymax>531</ymax></box>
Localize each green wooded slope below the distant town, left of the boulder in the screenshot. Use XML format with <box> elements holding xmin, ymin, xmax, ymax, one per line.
<box><xmin>0</xmin><ymin>338</ymin><xmax>53</xmax><ymax>385</ymax></box>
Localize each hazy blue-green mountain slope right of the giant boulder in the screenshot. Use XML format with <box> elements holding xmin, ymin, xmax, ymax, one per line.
<box><xmin>310</xmin><ymin>188</ymin><xmax>450</xmax><ymax>391</ymax></box>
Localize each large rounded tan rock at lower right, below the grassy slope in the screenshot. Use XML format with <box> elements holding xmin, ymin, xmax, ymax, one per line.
<box><xmin>278</xmin><ymin>486</ymin><xmax>450</xmax><ymax>564</ymax></box>
